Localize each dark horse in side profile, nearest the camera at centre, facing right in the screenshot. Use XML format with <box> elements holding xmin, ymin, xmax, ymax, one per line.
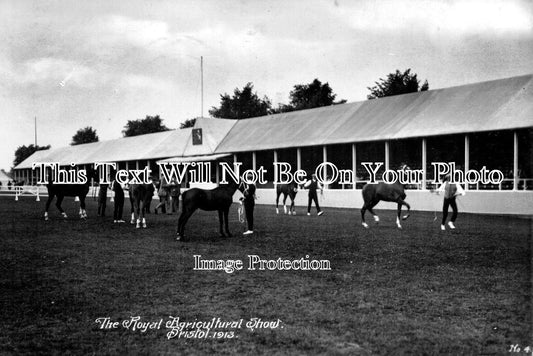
<box><xmin>176</xmin><ymin>181</ymin><xmax>244</xmax><ymax>241</ymax></box>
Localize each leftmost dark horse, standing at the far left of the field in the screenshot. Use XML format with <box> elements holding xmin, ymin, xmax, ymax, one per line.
<box><xmin>44</xmin><ymin>168</ymin><xmax>98</xmax><ymax>220</ymax></box>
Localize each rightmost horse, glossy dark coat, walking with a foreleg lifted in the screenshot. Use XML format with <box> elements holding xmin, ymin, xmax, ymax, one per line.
<box><xmin>361</xmin><ymin>182</ymin><xmax>411</xmax><ymax>229</ymax></box>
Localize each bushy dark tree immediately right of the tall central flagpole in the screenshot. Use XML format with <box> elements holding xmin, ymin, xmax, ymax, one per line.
<box><xmin>209</xmin><ymin>83</ymin><xmax>272</xmax><ymax>120</ymax></box>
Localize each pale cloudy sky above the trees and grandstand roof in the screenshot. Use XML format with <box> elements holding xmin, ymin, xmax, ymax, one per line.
<box><xmin>0</xmin><ymin>0</ymin><xmax>533</xmax><ymax>170</ymax></box>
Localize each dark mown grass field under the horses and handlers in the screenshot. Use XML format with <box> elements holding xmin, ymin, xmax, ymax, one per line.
<box><xmin>0</xmin><ymin>197</ymin><xmax>533</xmax><ymax>355</ymax></box>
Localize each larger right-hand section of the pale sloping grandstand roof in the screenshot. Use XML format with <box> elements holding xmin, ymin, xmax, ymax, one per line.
<box><xmin>216</xmin><ymin>75</ymin><xmax>533</xmax><ymax>152</ymax></box>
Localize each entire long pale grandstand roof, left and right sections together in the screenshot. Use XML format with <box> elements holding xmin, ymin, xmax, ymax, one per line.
<box><xmin>16</xmin><ymin>75</ymin><xmax>533</xmax><ymax>169</ymax></box>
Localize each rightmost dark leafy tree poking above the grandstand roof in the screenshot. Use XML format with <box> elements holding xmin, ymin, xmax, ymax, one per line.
<box><xmin>367</xmin><ymin>68</ymin><xmax>429</xmax><ymax>99</ymax></box>
